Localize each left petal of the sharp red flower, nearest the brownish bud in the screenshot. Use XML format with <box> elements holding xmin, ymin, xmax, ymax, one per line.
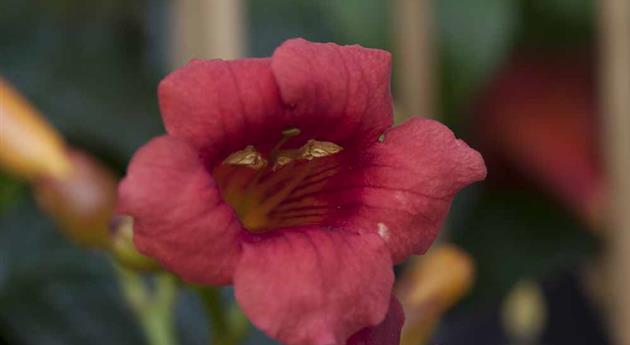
<box><xmin>118</xmin><ymin>136</ymin><xmax>242</xmax><ymax>284</ymax></box>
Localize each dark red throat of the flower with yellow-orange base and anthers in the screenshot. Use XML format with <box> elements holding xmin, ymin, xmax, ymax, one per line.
<box><xmin>213</xmin><ymin>129</ymin><xmax>343</xmax><ymax>232</ymax></box>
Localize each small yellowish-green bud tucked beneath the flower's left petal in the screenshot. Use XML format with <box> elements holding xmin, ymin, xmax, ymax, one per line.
<box><xmin>111</xmin><ymin>215</ymin><xmax>160</xmax><ymax>272</ymax></box>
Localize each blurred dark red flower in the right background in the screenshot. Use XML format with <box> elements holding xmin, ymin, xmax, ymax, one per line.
<box><xmin>475</xmin><ymin>53</ymin><xmax>604</xmax><ymax>224</ymax></box>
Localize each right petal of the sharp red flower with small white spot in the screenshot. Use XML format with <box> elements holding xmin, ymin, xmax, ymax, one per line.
<box><xmin>325</xmin><ymin>118</ymin><xmax>486</xmax><ymax>263</ymax></box>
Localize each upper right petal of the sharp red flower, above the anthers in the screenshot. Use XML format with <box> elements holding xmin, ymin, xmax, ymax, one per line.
<box><xmin>271</xmin><ymin>39</ymin><xmax>393</xmax><ymax>147</ymax></box>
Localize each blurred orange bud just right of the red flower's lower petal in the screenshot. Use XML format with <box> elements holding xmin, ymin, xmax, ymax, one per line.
<box><xmin>396</xmin><ymin>244</ymin><xmax>474</xmax><ymax>345</ymax></box>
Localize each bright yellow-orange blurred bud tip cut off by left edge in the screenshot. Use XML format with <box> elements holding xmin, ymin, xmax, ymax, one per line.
<box><xmin>0</xmin><ymin>78</ymin><xmax>70</xmax><ymax>179</ymax></box>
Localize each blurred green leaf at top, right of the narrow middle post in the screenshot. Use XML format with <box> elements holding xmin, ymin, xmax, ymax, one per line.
<box><xmin>435</xmin><ymin>0</ymin><xmax>520</xmax><ymax>120</ymax></box>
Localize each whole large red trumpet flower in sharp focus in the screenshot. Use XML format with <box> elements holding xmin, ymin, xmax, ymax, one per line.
<box><xmin>118</xmin><ymin>39</ymin><xmax>485</xmax><ymax>344</ymax></box>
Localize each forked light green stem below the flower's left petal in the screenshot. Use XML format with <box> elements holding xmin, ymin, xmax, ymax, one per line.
<box><xmin>115</xmin><ymin>265</ymin><xmax>177</xmax><ymax>345</ymax></box>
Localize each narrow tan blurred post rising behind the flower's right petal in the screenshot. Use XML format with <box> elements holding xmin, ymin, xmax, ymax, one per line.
<box><xmin>392</xmin><ymin>0</ymin><xmax>435</xmax><ymax>120</ymax></box>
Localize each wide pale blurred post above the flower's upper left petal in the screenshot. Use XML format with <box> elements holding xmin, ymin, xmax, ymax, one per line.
<box><xmin>170</xmin><ymin>0</ymin><xmax>246</xmax><ymax>68</ymax></box>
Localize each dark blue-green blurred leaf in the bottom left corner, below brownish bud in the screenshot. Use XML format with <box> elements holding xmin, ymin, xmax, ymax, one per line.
<box><xmin>0</xmin><ymin>198</ymin><xmax>142</xmax><ymax>345</ymax></box>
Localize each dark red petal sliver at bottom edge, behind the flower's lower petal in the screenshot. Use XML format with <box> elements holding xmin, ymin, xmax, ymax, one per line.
<box><xmin>347</xmin><ymin>296</ymin><xmax>405</xmax><ymax>345</ymax></box>
